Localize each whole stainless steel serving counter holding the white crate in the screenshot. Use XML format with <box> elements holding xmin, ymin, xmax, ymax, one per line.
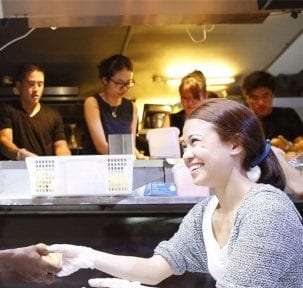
<box><xmin>0</xmin><ymin>160</ymin><xmax>303</xmax><ymax>214</ymax></box>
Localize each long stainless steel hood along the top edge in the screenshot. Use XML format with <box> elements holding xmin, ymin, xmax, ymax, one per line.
<box><xmin>2</xmin><ymin>0</ymin><xmax>269</xmax><ymax>27</ymax></box>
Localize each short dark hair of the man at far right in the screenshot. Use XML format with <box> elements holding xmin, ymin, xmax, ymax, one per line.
<box><xmin>241</xmin><ymin>71</ymin><xmax>276</xmax><ymax>95</ymax></box>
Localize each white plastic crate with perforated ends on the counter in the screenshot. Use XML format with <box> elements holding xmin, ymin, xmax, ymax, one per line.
<box><xmin>25</xmin><ymin>155</ymin><xmax>134</xmax><ymax>197</ymax></box>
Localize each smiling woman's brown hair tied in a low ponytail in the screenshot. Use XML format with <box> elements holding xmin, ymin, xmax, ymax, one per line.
<box><xmin>187</xmin><ymin>99</ymin><xmax>286</xmax><ymax>190</ymax></box>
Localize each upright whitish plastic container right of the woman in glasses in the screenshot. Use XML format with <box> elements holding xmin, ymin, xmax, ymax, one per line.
<box><xmin>146</xmin><ymin>127</ymin><xmax>181</xmax><ymax>159</ymax></box>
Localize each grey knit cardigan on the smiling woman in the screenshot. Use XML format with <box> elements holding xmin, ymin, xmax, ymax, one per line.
<box><xmin>154</xmin><ymin>184</ymin><xmax>303</xmax><ymax>288</ymax></box>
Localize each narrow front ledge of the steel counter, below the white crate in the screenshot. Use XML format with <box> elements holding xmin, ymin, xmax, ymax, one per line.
<box><xmin>0</xmin><ymin>196</ymin><xmax>201</xmax><ymax>214</ymax></box>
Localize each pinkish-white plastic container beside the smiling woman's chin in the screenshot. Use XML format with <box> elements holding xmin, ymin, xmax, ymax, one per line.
<box><xmin>172</xmin><ymin>163</ymin><xmax>209</xmax><ymax>197</ymax></box>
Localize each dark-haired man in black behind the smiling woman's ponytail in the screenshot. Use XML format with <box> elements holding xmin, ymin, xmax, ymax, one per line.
<box><xmin>242</xmin><ymin>71</ymin><xmax>303</xmax><ymax>141</ymax></box>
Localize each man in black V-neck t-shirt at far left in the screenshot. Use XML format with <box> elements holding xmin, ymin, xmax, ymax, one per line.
<box><xmin>0</xmin><ymin>64</ymin><xmax>71</xmax><ymax>160</ymax></box>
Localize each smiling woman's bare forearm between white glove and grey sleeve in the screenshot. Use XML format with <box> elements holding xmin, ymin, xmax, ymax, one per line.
<box><xmin>95</xmin><ymin>251</ymin><xmax>172</xmax><ymax>285</ymax></box>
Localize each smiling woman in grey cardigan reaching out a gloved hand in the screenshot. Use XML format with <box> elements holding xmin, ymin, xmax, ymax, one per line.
<box><xmin>51</xmin><ymin>99</ymin><xmax>303</xmax><ymax>288</ymax></box>
